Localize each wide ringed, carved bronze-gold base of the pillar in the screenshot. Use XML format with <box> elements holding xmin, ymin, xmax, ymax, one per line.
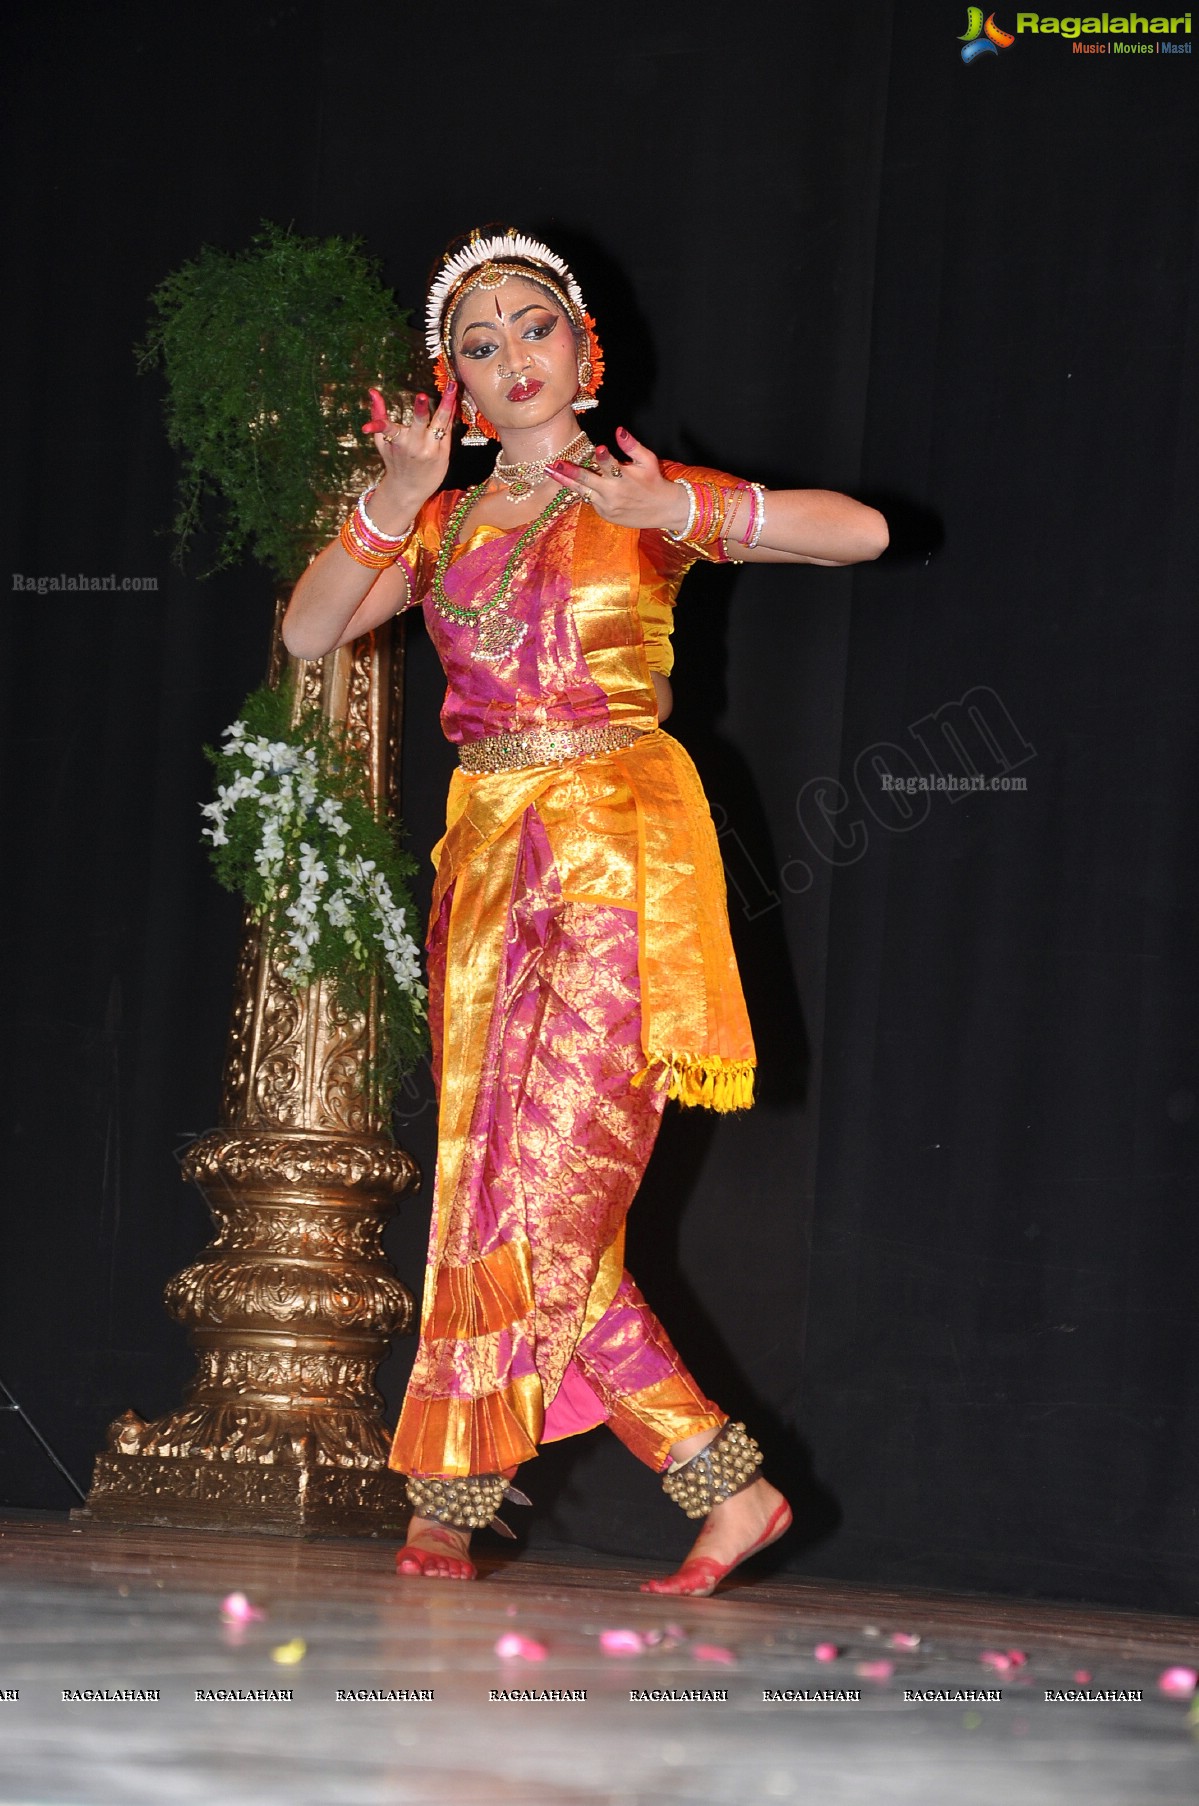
<box><xmin>88</xmin><ymin>1129</ymin><xmax>415</xmax><ymax>1535</ymax></box>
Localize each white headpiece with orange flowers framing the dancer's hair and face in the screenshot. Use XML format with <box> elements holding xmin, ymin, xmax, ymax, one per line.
<box><xmin>424</xmin><ymin>226</ymin><xmax>603</xmax><ymax>439</ymax></box>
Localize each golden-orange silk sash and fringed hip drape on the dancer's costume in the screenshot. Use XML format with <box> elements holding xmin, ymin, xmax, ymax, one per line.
<box><xmin>433</xmin><ymin>491</ymin><xmax>755</xmax><ymax>1256</ymax></box>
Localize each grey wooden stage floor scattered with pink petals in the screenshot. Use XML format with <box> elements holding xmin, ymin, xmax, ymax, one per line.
<box><xmin>0</xmin><ymin>1513</ymin><xmax>1199</xmax><ymax>1806</ymax></box>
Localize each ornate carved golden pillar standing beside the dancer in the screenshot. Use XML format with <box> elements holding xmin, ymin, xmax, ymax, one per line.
<box><xmin>79</xmin><ymin>598</ymin><xmax>417</xmax><ymax>1535</ymax></box>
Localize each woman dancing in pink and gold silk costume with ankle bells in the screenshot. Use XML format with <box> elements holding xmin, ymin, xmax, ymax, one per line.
<box><xmin>283</xmin><ymin>231</ymin><xmax>887</xmax><ymax>1593</ymax></box>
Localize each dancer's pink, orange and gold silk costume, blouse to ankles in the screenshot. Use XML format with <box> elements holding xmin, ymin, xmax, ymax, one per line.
<box><xmin>390</xmin><ymin>464</ymin><xmax>755</xmax><ymax>1476</ymax></box>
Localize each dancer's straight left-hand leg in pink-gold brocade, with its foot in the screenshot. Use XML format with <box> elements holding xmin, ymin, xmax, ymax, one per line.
<box><xmin>394</xmin><ymin>852</ymin><xmax>663</xmax><ymax>1578</ymax></box>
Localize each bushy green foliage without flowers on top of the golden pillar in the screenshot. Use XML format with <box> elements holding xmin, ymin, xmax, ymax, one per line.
<box><xmin>137</xmin><ymin>222</ymin><xmax>415</xmax><ymax>582</ymax></box>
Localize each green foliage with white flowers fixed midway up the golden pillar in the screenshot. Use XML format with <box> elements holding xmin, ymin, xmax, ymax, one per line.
<box><xmin>200</xmin><ymin>686</ymin><xmax>428</xmax><ymax>1105</ymax></box>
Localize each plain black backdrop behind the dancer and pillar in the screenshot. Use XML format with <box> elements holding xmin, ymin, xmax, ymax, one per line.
<box><xmin>0</xmin><ymin>0</ymin><xmax>1199</xmax><ymax>1609</ymax></box>
